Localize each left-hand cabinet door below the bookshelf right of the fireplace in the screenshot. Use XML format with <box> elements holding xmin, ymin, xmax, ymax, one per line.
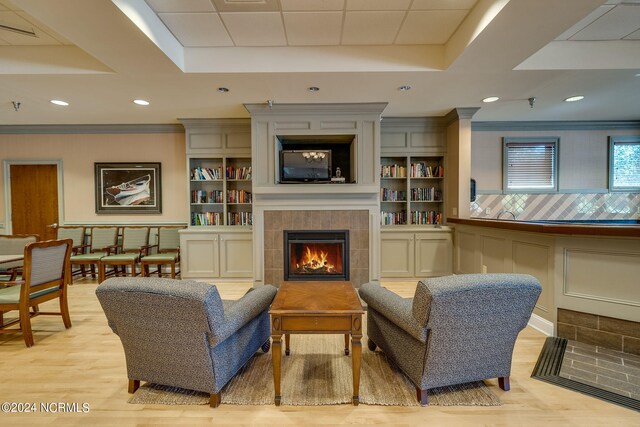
<box><xmin>380</xmin><ymin>233</ymin><xmax>414</xmax><ymax>278</ymax></box>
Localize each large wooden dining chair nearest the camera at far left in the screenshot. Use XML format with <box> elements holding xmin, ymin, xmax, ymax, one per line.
<box><xmin>0</xmin><ymin>239</ymin><xmax>73</xmax><ymax>347</ymax></box>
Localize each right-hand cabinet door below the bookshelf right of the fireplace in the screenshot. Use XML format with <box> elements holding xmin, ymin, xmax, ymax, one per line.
<box><xmin>415</xmin><ymin>233</ymin><xmax>453</xmax><ymax>278</ymax></box>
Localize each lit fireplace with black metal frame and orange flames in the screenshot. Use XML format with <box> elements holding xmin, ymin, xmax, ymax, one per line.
<box><xmin>283</xmin><ymin>230</ymin><xmax>349</xmax><ymax>281</ymax></box>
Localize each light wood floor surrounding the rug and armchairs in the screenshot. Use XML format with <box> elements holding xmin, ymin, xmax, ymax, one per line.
<box><xmin>0</xmin><ymin>280</ymin><xmax>640</xmax><ymax>426</ymax></box>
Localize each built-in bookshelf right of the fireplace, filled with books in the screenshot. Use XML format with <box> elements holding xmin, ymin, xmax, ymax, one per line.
<box><xmin>380</xmin><ymin>156</ymin><xmax>445</xmax><ymax>226</ymax></box>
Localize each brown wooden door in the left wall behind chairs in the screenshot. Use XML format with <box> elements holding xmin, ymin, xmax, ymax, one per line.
<box><xmin>9</xmin><ymin>165</ymin><xmax>58</xmax><ymax>240</ymax></box>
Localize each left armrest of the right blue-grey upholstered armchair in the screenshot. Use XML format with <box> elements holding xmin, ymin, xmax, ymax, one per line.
<box><xmin>359</xmin><ymin>283</ymin><xmax>427</xmax><ymax>342</ymax></box>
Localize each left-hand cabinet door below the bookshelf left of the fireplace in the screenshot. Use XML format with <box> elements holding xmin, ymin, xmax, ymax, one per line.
<box><xmin>180</xmin><ymin>233</ymin><xmax>220</xmax><ymax>279</ymax></box>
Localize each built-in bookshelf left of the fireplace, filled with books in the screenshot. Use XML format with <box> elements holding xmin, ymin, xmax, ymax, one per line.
<box><xmin>189</xmin><ymin>157</ymin><xmax>253</xmax><ymax>226</ymax></box>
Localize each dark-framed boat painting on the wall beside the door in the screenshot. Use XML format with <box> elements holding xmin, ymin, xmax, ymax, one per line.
<box><xmin>95</xmin><ymin>163</ymin><xmax>162</xmax><ymax>215</ymax></box>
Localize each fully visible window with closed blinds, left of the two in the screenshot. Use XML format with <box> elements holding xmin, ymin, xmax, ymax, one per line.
<box><xmin>503</xmin><ymin>138</ymin><xmax>558</xmax><ymax>192</ymax></box>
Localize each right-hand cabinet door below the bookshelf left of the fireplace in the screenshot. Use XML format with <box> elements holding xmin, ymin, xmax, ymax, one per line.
<box><xmin>220</xmin><ymin>233</ymin><xmax>253</xmax><ymax>278</ymax></box>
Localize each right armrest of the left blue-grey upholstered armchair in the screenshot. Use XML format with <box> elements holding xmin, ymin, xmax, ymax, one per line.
<box><xmin>211</xmin><ymin>285</ymin><xmax>277</xmax><ymax>345</ymax></box>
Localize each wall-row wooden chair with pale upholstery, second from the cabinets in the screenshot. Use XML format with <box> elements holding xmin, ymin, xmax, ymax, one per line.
<box><xmin>98</xmin><ymin>226</ymin><xmax>149</xmax><ymax>283</ymax></box>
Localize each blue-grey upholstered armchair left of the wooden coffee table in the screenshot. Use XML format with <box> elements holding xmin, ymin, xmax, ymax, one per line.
<box><xmin>96</xmin><ymin>277</ymin><xmax>276</xmax><ymax>408</ymax></box>
